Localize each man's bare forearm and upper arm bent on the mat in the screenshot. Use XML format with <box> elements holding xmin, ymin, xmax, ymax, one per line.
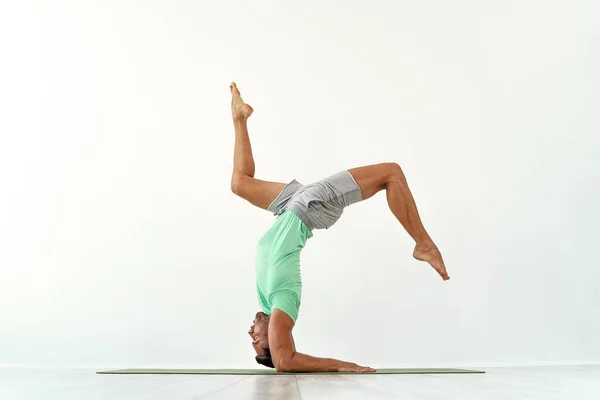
<box><xmin>269</xmin><ymin>309</ymin><xmax>375</xmax><ymax>372</ymax></box>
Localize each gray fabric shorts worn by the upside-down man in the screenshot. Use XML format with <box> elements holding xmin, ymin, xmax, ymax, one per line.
<box><xmin>268</xmin><ymin>171</ymin><xmax>362</xmax><ymax>230</ymax></box>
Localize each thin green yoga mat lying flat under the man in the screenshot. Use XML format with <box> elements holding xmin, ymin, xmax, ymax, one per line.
<box><xmin>97</xmin><ymin>368</ymin><xmax>485</xmax><ymax>375</ymax></box>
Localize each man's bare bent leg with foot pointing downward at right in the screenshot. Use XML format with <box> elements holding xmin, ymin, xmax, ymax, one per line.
<box><xmin>348</xmin><ymin>163</ymin><xmax>450</xmax><ymax>280</ymax></box>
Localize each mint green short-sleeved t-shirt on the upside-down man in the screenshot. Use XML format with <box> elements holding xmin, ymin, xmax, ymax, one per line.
<box><xmin>256</xmin><ymin>211</ymin><xmax>312</xmax><ymax>323</ymax></box>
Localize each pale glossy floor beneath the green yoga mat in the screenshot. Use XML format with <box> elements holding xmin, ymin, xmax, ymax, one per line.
<box><xmin>0</xmin><ymin>366</ymin><xmax>600</xmax><ymax>400</ymax></box>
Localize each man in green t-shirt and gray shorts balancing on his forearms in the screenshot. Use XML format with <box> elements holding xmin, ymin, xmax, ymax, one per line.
<box><xmin>230</xmin><ymin>83</ymin><xmax>450</xmax><ymax>372</ymax></box>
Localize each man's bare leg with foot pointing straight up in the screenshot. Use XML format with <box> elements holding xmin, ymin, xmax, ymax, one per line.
<box><xmin>230</xmin><ymin>83</ymin><xmax>285</xmax><ymax>210</ymax></box>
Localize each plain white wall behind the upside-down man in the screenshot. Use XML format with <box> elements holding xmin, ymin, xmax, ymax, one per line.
<box><xmin>0</xmin><ymin>0</ymin><xmax>600</xmax><ymax>367</ymax></box>
